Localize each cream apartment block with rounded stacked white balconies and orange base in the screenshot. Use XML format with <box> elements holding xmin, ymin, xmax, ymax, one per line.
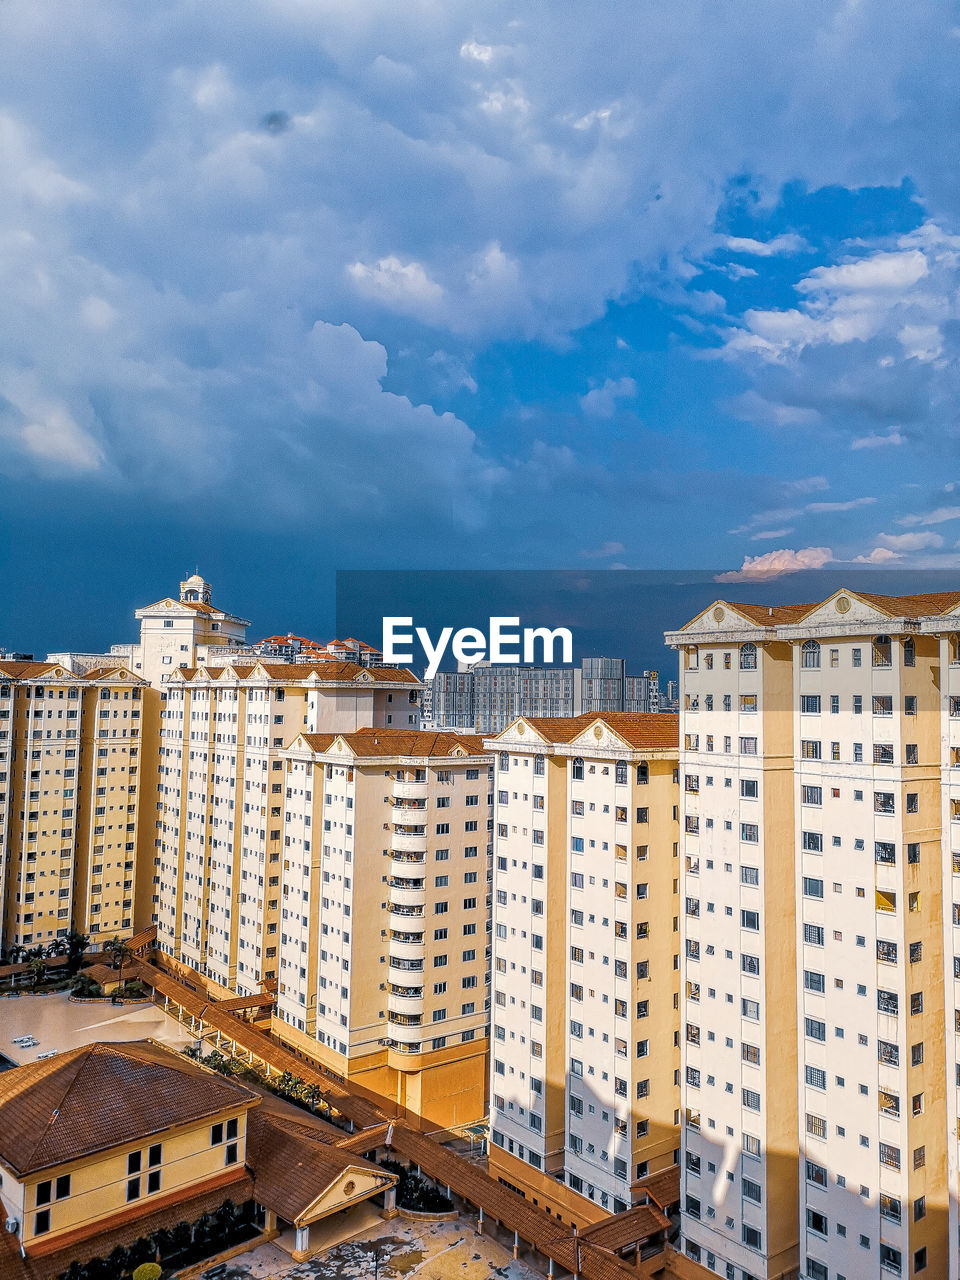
<box><xmin>274</xmin><ymin>727</ymin><xmax>493</xmax><ymax>1128</ymax></box>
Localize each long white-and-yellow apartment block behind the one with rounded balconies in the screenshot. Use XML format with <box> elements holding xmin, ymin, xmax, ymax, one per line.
<box><xmin>151</xmin><ymin>662</ymin><xmax>420</xmax><ymax>995</ymax></box>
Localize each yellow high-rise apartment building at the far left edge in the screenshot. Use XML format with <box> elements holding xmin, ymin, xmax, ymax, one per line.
<box><xmin>0</xmin><ymin>662</ymin><xmax>148</xmax><ymax>948</ymax></box>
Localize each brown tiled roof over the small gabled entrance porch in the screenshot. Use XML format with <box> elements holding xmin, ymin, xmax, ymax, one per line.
<box><xmin>247</xmin><ymin>1108</ymin><xmax>396</xmax><ymax>1222</ymax></box>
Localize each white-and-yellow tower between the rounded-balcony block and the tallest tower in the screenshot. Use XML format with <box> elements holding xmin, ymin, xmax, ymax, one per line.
<box><xmin>486</xmin><ymin>713</ymin><xmax>680</xmax><ymax>1224</ymax></box>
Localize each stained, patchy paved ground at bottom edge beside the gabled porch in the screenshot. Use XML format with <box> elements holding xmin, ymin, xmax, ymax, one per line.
<box><xmin>194</xmin><ymin>1217</ymin><xmax>543</xmax><ymax>1280</ymax></box>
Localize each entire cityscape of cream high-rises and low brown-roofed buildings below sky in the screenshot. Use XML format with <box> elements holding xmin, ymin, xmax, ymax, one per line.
<box><xmin>0</xmin><ymin>573</ymin><xmax>960</xmax><ymax>1280</ymax></box>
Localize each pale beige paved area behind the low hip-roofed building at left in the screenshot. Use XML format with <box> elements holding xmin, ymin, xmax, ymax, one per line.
<box><xmin>0</xmin><ymin>992</ymin><xmax>193</xmax><ymax>1066</ymax></box>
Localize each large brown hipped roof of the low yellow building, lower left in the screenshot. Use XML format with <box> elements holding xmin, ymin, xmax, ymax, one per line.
<box><xmin>0</xmin><ymin>1044</ymin><xmax>260</xmax><ymax>1176</ymax></box>
